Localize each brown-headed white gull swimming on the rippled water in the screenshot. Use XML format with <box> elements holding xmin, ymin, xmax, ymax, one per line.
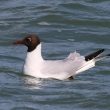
<box><xmin>14</xmin><ymin>34</ymin><xmax>110</xmax><ymax>80</ymax></box>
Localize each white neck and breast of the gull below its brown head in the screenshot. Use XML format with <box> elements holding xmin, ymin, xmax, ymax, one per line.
<box><xmin>23</xmin><ymin>44</ymin><xmax>43</xmax><ymax>77</ymax></box>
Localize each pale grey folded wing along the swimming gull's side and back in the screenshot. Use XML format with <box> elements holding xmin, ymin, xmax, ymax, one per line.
<box><xmin>42</xmin><ymin>52</ymin><xmax>85</xmax><ymax>79</ymax></box>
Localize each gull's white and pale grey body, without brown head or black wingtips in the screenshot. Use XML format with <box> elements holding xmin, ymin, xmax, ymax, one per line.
<box><xmin>23</xmin><ymin>44</ymin><xmax>95</xmax><ymax>80</ymax></box>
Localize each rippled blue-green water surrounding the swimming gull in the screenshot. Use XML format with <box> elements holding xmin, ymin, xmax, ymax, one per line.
<box><xmin>0</xmin><ymin>0</ymin><xmax>110</xmax><ymax>110</ymax></box>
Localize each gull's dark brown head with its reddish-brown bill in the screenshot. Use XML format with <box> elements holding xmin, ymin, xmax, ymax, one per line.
<box><xmin>14</xmin><ymin>34</ymin><xmax>40</xmax><ymax>52</ymax></box>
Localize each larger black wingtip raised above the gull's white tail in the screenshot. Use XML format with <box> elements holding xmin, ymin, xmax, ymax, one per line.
<box><xmin>85</xmin><ymin>49</ymin><xmax>105</xmax><ymax>61</ymax></box>
